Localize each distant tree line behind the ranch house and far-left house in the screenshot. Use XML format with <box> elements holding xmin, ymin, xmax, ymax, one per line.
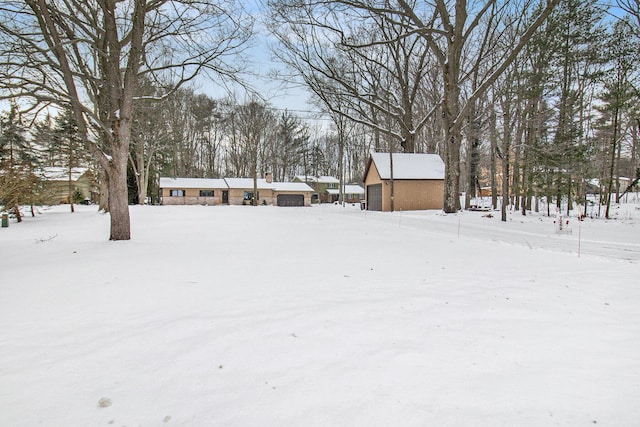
<box><xmin>0</xmin><ymin>90</ymin><xmax>369</xmax><ymax>210</ymax></box>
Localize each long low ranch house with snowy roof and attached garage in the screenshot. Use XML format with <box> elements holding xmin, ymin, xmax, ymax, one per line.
<box><xmin>160</xmin><ymin>174</ymin><xmax>313</xmax><ymax>206</ymax></box>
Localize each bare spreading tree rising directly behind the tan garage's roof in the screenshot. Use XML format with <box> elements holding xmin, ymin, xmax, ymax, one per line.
<box><xmin>269</xmin><ymin>0</ymin><xmax>432</xmax><ymax>152</ymax></box>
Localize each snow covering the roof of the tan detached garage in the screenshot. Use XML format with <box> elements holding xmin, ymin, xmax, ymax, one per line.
<box><xmin>371</xmin><ymin>153</ymin><xmax>444</xmax><ymax>179</ymax></box>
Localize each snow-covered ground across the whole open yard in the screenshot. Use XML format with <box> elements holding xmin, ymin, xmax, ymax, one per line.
<box><xmin>0</xmin><ymin>205</ymin><xmax>640</xmax><ymax>427</ymax></box>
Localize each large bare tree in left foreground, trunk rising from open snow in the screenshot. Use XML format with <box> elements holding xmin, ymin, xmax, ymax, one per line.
<box><xmin>0</xmin><ymin>0</ymin><xmax>252</xmax><ymax>240</ymax></box>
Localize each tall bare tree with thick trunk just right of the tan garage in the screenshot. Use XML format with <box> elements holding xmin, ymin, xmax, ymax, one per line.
<box><xmin>398</xmin><ymin>0</ymin><xmax>560</xmax><ymax>212</ymax></box>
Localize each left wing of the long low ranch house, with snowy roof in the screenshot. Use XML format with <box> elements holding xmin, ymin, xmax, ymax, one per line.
<box><xmin>159</xmin><ymin>177</ymin><xmax>229</xmax><ymax>205</ymax></box>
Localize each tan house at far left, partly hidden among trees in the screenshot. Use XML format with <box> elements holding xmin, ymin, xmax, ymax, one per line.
<box><xmin>37</xmin><ymin>166</ymin><xmax>98</xmax><ymax>203</ymax></box>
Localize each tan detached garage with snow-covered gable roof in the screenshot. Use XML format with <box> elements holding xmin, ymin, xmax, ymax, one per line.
<box><xmin>364</xmin><ymin>153</ymin><xmax>444</xmax><ymax>211</ymax></box>
